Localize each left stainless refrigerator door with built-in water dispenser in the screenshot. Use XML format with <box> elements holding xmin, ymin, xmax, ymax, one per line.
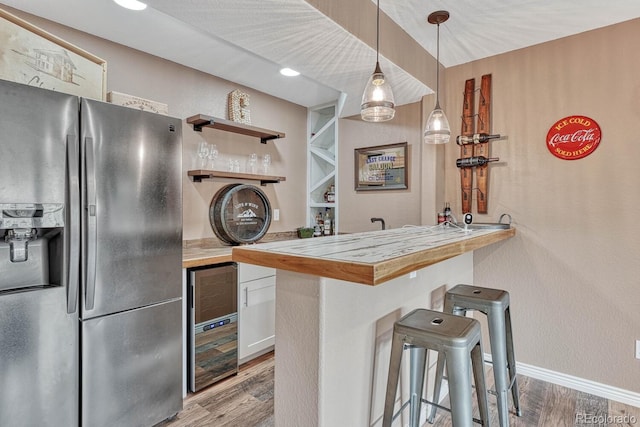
<box><xmin>0</xmin><ymin>80</ymin><xmax>79</xmax><ymax>427</ymax></box>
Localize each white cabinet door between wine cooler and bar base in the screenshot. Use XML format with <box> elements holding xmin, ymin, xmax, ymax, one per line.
<box><xmin>238</xmin><ymin>276</ymin><xmax>276</xmax><ymax>362</ymax></box>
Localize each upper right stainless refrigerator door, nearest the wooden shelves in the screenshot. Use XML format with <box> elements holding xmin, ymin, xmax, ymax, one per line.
<box><xmin>81</xmin><ymin>99</ymin><xmax>182</xmax><ymax>319</ymax></box>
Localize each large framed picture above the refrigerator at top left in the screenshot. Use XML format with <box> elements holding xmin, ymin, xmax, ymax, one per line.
<box><xmin>0</xmin><ymin>9</ymin><xmax>107</xmax><ymax>101</ymax></box>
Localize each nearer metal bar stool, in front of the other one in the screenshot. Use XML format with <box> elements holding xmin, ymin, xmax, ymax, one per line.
<box><xmin>382</xmin><ymin>309</ymin><xmax>489</xmax><ymax>427</ymax></box>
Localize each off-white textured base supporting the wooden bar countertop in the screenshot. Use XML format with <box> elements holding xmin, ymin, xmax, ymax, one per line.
<box><xmin>275</xmin><ymin>252</ymin><xmax>473</xmax><ymax>427</ymax></box>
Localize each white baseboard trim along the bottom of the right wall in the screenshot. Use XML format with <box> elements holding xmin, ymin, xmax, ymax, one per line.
<box><xmin>485</xmin><ymin>354</ymin><xmax>640</xmax><ymax>408</ymax></box>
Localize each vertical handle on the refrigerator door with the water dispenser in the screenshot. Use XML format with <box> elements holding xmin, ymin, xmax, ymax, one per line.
<box><xmin>66</xmin><ymin>135</ymin><xmax>80</xmax><ymax>314</ymax></box>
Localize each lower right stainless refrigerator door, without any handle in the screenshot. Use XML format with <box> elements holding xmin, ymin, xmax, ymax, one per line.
<box><xmin>82</xmin><ymin>299</ymin><xmax>182</xmax><ymax>427</ymax></box>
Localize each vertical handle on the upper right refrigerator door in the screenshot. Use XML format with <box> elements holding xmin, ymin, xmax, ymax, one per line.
<box><xmin>84</xmin><ymin>138</ymin><xmax>98</xmax><ymax>310</ymax></box>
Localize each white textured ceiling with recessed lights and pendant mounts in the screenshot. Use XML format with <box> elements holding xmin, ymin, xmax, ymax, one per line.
<box><xmin>0</xmin><ymin>0</ymin><xmax>640</xmax><ymax>117</ymax></box>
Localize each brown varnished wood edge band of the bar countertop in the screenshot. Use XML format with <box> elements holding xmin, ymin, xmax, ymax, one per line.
<box><xmin>231</xmin><ymin>228</ymin><xmax>516</xmax><ymax>286</ymax></box>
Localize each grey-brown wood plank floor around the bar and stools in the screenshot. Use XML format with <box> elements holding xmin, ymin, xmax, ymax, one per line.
<box><xmin>158</xmin><ymin>353</ymin><xmax>640</xmax><ymax>427</ymax></box>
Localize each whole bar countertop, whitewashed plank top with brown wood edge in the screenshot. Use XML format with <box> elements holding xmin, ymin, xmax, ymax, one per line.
<box><xmin>232</xmin><ymin>226</ymin><xmax>516</xmax><ymax>285</ymax></box>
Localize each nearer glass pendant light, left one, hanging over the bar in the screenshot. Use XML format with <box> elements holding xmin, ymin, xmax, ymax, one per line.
<box><xmin>360</xmin><ymin>0</ymin><xmax>396</xmax><ymax>122</ymax></box>
